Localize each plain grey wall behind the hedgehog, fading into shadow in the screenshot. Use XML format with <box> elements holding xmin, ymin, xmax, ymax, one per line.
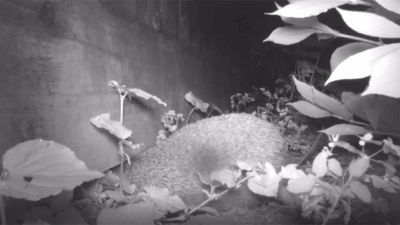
<box><xmin>0</xmin><ymin>0</ymin><xmax>253</xmax><ymax>170</ymax></box>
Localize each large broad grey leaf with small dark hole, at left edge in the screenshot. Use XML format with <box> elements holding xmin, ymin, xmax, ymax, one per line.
<box><xmin>0</xmin><ymin>139</ymin><xmax>103</xmax><ymax>201</ymax></box>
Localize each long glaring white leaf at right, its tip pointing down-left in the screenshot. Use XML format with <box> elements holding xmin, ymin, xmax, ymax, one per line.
<box><xmin>325</xmin><ymin>44</ymin><xmax>400</xmax><ymax>85</ymax></box>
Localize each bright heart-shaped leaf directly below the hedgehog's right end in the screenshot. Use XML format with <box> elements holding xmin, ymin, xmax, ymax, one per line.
<box><xmin>247</xmin><ymin>162</ymin><xmax>282</xmax><ymax>198</ymax></box>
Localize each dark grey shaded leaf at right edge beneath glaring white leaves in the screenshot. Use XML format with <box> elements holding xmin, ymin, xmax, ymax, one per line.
<box><xmin>342</xmin><ymin>92</ymin><xmax>400</xmax><ymax>134</ymax></box>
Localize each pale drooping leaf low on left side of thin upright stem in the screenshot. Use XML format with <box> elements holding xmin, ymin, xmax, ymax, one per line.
<box><xmin>90</xmin><ymin>113</ymin><xmax>132</xmax><ymax>140</ymax></box>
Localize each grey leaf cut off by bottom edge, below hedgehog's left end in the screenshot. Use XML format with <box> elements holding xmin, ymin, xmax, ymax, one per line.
<box><xmin>97</xmin><ymin>202</ymin><xmax>157</xmax><ymax>225</ymax></box>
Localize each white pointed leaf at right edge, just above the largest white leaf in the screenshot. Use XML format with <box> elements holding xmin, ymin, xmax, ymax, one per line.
<box><xmin>336</xmin><ymin>8</ymin><xmax>400</xmax><ymax>38</ymax></box>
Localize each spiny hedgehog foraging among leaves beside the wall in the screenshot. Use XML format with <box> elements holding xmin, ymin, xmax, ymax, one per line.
<box><xmin>129</xmin><ymin>113</ymin><xmax>285</xmax><ymax>210</ymax></box>
